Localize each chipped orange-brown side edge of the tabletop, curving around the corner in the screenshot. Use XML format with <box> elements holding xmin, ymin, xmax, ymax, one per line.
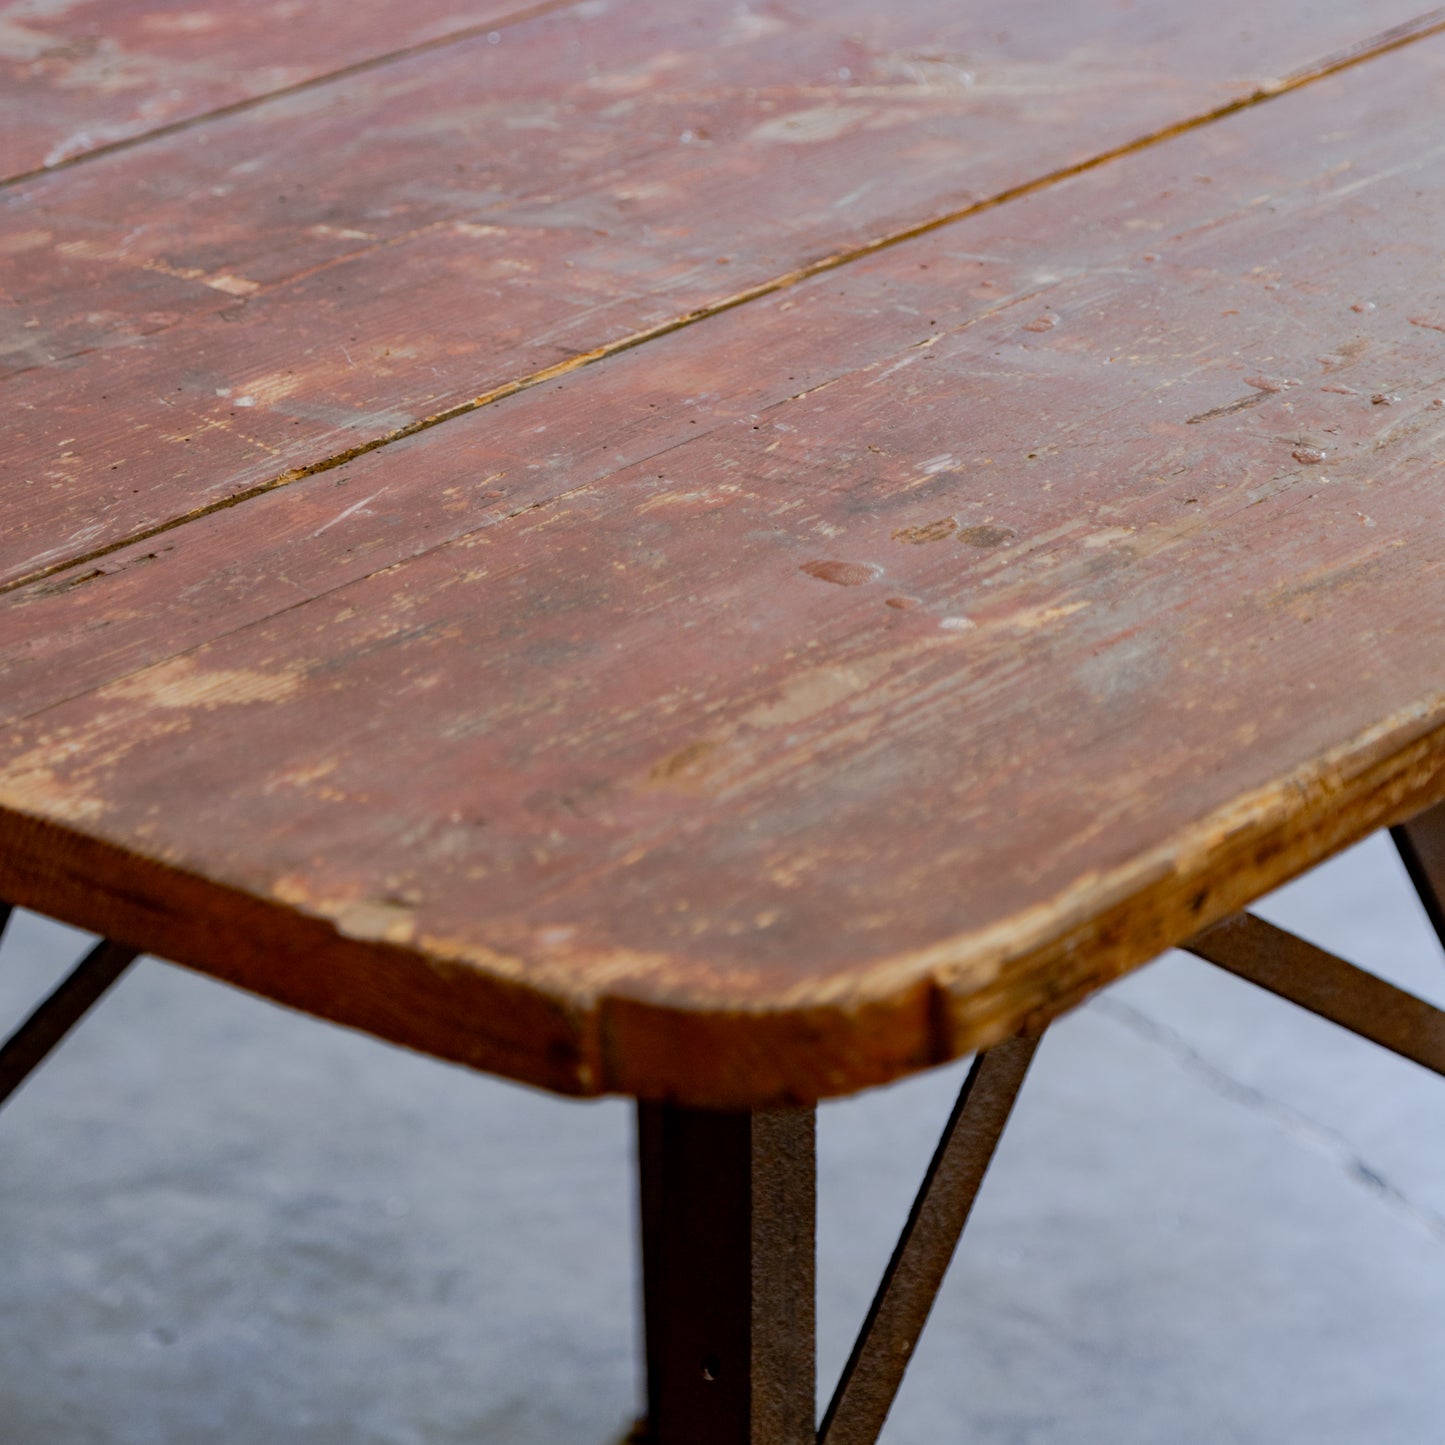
<box><xmin>0</xmin><ymin>692</ymin><xmax>1445</xmax><ymax>1108</ymax></box>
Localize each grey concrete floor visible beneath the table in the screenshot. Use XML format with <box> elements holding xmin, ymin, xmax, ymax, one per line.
<box><xmin>0</xmin><ymin>838</ymin><xmax>1445</xmax><ymax>1445</ymax></box>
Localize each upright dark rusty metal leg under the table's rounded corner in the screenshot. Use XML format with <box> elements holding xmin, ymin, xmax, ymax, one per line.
<box><xmin>637</xmin><ymin>1103</ymin><xmax>816</xmax><ymax>1445</ymax></box>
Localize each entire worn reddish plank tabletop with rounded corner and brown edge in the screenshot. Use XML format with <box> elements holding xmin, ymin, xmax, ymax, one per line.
<box><xmin>0</xmin><ymin>0</ymin><xmax>1445</xmax><ymax>1107</ymax></box>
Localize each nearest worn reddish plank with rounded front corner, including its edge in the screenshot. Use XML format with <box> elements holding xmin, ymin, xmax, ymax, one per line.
<box><xmin>0</xmin><ymin>43</ymin><xmax>1445</xmax><ymax>1107</ymax></box>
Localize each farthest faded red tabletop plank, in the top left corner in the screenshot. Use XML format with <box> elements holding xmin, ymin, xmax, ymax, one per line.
<box><xmin>0</xmin><ymin>0</ymin><xmax>566</xmax><ymax>179</ymax></box>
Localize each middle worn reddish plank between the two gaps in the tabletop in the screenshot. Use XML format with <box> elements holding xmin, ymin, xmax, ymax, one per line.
<box><xmin>0</xmin><ymin>0</ymin><xmax>1441</xmax><ymax>585</ymax></box>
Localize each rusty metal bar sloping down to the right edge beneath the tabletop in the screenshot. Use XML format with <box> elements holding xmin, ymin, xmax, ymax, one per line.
<box><xmin>1181</xmin><ymin>913</ymin><xmax>1445</xmax><ymax>1074</ymax></box>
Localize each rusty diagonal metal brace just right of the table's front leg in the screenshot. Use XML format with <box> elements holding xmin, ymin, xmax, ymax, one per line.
<box><xmin>818</xmin><ymin>1038</ymin><xmax>1039</xmax><ymax>1445</ymax></box>
